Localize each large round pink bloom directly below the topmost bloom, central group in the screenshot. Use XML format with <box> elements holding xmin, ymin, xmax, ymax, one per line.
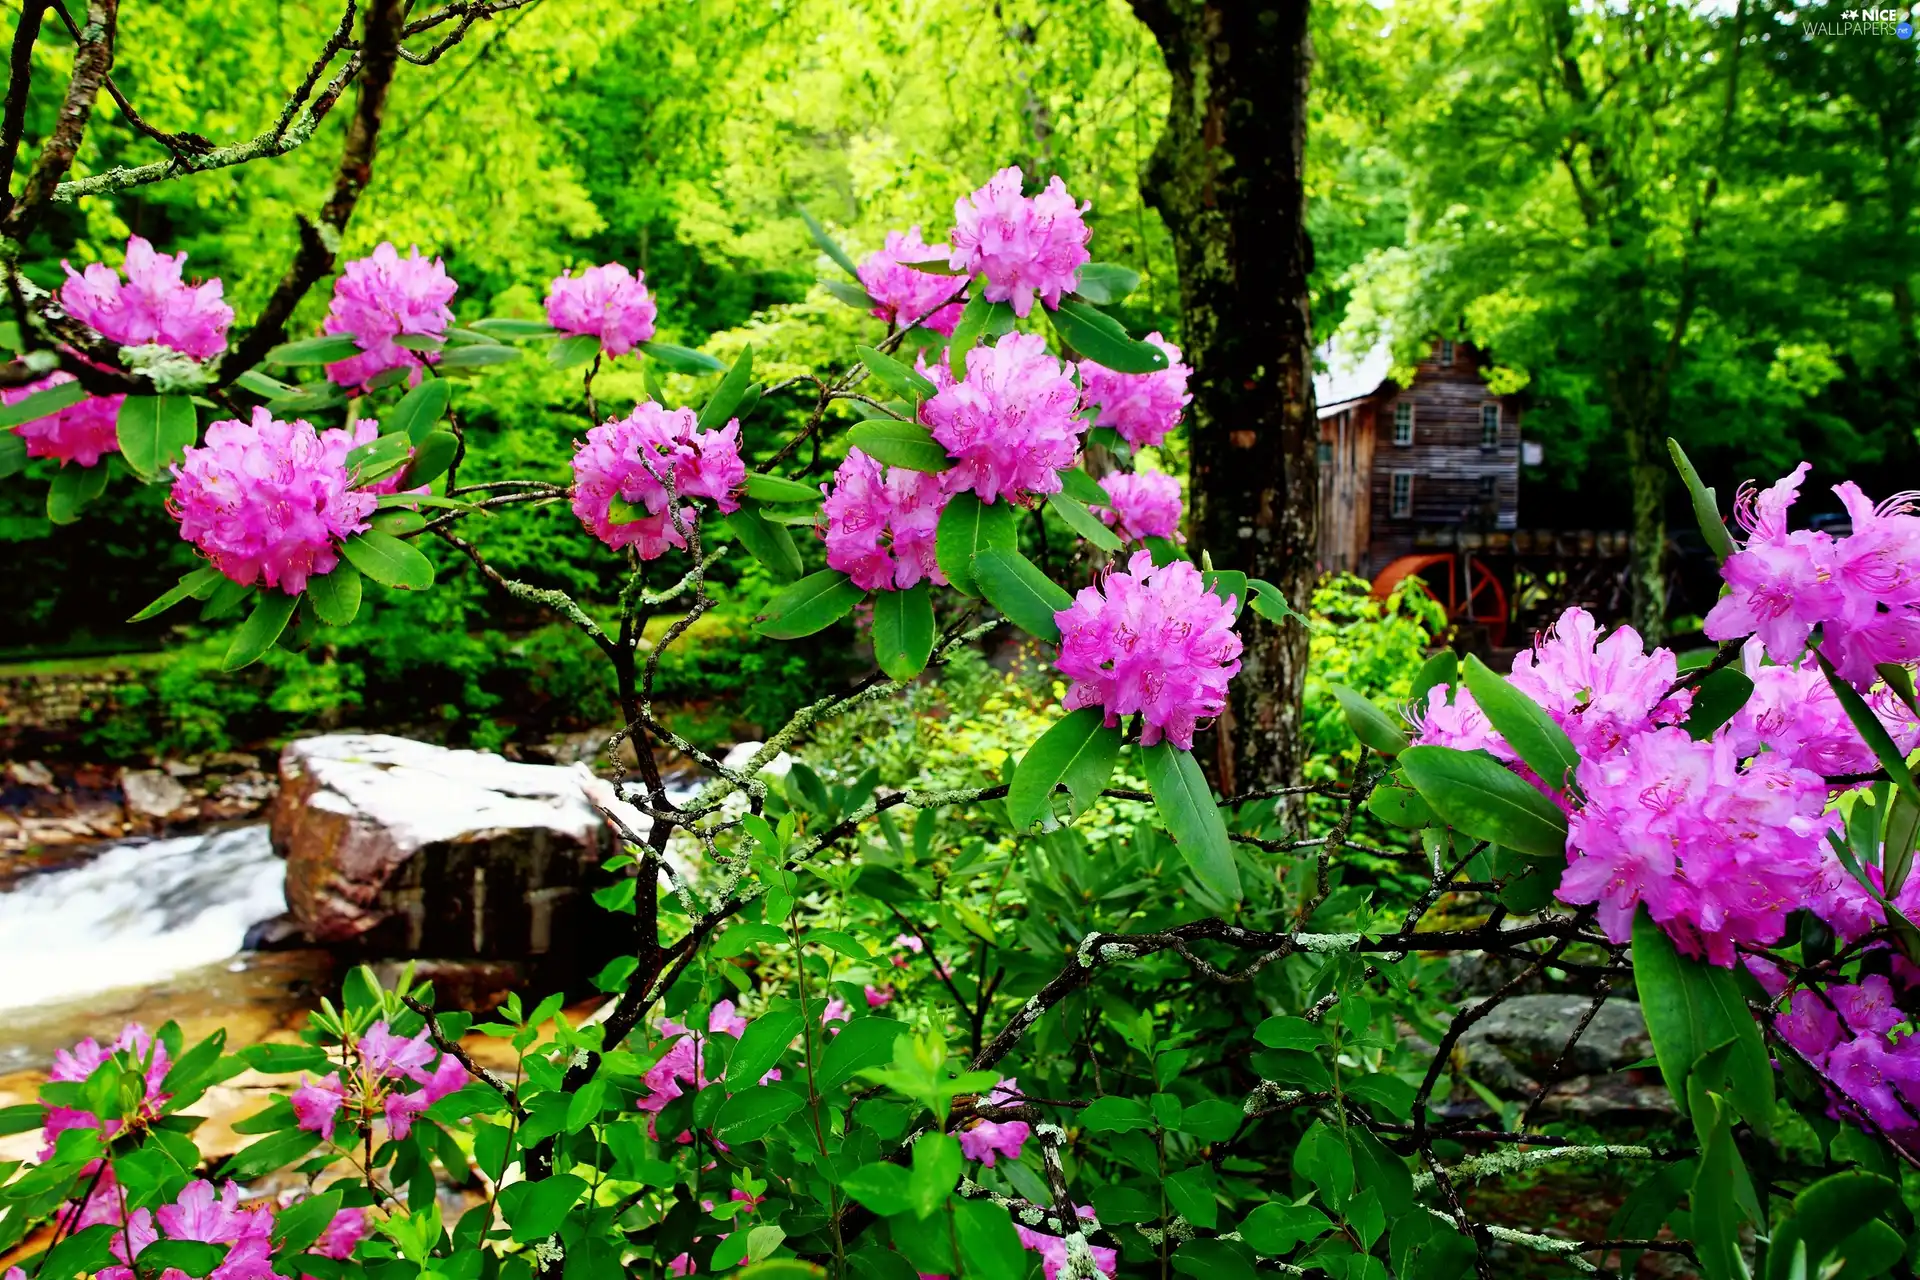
<box><xmin>920</xmin><ymin>334</ymin><xmax>1087</xmax><ymax>503</ymax></box>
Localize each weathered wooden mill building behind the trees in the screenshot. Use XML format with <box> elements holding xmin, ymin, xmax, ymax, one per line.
<box><xmin>1313</xmin><ymin>342</ymin><xmax>1536</xmax><ymax>578</ymax></box>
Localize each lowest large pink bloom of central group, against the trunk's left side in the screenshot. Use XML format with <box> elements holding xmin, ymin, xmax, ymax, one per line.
<box><xmin>1054</xmin><ymin>551</ymin><xmax>1240</xmax><ymax>750</ymax></box>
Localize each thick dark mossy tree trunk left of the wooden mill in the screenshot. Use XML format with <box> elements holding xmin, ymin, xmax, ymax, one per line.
<box><xmin>1133</xmin><ymin>0</ymin><xmax>1319</xmax><ymax>793</ymax></box>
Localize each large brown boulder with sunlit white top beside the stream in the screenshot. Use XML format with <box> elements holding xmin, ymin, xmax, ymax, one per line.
<box><xmin>273</xmin><ymin>733</ymin><xmax>620</xmax><ymax>983</ymax></box>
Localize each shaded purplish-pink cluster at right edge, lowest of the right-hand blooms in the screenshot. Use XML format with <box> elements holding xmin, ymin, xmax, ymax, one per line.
<box><xmin>1774</xmin><ymin>975</ymin><xmax>1920</xmax><ymax>1148</ymax></box>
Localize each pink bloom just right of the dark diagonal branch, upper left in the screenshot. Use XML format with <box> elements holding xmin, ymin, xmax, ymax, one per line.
<box><xmin>321</xmin><ymin>244</ymin><xmax>459</xmax><ymax>388</ymax></box>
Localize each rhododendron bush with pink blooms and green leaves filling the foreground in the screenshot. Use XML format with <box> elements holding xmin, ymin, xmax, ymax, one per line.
<box><xmin>0</xmin><ymin>17</ymin><xmax>1920</xmax><ymax>1280</ymax></box>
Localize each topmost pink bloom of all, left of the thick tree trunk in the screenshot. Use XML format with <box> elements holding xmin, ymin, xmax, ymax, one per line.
<box><xmin>948</xmin><ymin>167</ymin><xmax>1092</xmax><ymax>315</ymax></box>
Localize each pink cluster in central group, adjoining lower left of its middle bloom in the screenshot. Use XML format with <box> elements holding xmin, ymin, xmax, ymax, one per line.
<box><xmin>822</xmin><ymin>449</ymin><xmax>947</xmax><ymax>591</ymax></box>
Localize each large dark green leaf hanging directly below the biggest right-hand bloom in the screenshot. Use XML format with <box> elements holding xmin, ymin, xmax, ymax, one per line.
<box><xmin>1634</xmin><ymin>908</ymin><xmax>1774</xmax><ymax>1136</ymax></box>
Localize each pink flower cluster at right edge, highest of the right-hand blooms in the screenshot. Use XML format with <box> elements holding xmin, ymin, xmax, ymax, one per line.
<box><xmin>1705</xmin><ymin>462</ymin><xmax>1920</xmax><ymax>691</ymax></box>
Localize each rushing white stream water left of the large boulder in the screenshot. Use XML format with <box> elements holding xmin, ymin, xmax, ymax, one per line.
<box><xmin>0</xmin><ymin>823</ymin><xmax>286</xmax><ymax>1009</ymax></box>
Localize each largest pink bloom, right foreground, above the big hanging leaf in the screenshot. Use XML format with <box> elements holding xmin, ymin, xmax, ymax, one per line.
<box><xmin>1559</xmin><ymin>729</ymin><xmax>1837</xmax><ymax>965</ymax></box>
